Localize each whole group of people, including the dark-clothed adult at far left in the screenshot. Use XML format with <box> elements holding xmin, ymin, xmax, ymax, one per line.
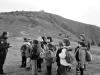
<box><xmin>0</xmin><ymin>32</ymin><xmax>90</xmax><ymax>75</ymax></box>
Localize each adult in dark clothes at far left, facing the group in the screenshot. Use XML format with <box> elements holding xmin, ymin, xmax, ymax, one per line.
<box><xmin>0</xmin><ymin>32</ymin><xmax>10</xmax><ymax>75</ymax></box>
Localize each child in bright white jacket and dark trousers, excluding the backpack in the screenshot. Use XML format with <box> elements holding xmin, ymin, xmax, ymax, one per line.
<box><xmin>59</xmin><ymin>38</ymin><xmax>71</xmax><ymax>75</ymax></box>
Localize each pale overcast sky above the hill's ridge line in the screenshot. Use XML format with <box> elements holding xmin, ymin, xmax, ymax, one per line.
<box><xmin>0</xmin><ymin>0</ymin><xmax>100</xmax><ymax>27</ymax></box>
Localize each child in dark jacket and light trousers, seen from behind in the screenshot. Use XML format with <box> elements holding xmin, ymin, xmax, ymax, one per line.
<box><xmin>30</xmin><ymin>40</ymin><xmax>40</xmax><ymax>75</ymax></box>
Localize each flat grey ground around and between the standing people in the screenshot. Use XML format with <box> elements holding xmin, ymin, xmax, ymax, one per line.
<box><xmin>4</xmin><ymin>39</ymin><xmax>100</xmax><ymax>75</ymax></box>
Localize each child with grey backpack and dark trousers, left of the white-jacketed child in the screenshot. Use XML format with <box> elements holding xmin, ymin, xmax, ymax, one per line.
<box><xmin>44</xmin><ymin>43</ymin><xmax>55</xmax><ymax>75</ymax></box>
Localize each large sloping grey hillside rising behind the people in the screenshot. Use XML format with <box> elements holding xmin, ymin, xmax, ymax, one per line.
<box><xmin>0</xmin><ymin>11</ymin><xmax>100</xmax><ymax>45</ymax></box>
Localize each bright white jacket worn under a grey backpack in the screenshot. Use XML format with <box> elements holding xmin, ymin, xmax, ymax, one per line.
<box><xmin>59</xmin><ymin>48</ymin><xmax>71</xmax><ymax>66</ymax></box>
